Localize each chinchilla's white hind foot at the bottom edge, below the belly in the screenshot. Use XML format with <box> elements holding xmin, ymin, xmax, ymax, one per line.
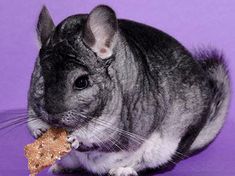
<box><xmin>109</xmin><ymin>167</ymin><xmax>138</xmax><ymax>176</ymax></box>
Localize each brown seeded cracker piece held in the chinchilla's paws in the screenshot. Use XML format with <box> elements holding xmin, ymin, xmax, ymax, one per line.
<box><xmin>24</xmin><ymin>128</ymin><xmax>71</xmax><ymax>176</ymax></box>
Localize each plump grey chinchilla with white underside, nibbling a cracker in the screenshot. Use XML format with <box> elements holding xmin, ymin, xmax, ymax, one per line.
<box><xmin>28</xmin><ymin>5</ymin><xmax>230</xmax><ymax>176</ymax></box>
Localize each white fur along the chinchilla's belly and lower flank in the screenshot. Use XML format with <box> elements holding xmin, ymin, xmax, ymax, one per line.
<box><xmin>62</xmin><ymin>132</ymin><xmax>180</xmax><ymax>174</ymax></box>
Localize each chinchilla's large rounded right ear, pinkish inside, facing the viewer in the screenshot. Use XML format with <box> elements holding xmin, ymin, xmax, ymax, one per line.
<box><xmin>83</xmin><ymin>5</ymin><xmax>118</xmax><ymax>59</ymax></box>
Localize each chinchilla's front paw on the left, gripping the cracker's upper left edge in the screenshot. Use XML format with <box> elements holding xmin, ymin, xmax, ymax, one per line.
<box><xmin>28</xmin><ymin>118</ymin><xmax>50</xmax><ymax>139</ymax></box>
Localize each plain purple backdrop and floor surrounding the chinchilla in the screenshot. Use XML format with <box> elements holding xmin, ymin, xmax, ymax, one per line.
<box><xmin>0</xmin><ymin>0</ymin><xmax>235</xmax><ymax>176</ymax></box>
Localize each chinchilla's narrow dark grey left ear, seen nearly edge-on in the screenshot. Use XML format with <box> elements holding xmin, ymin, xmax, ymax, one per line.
<box><xmin>37</xmin><ymin>6</ymin><xmax>55</xmax><ymax>45</ymax></box>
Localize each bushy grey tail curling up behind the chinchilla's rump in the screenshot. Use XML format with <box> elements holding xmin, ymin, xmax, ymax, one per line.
<box><xmin>191</xmin><ymin>50</ymin><xmax>230</xmax><ymax>150</ymax></box>
